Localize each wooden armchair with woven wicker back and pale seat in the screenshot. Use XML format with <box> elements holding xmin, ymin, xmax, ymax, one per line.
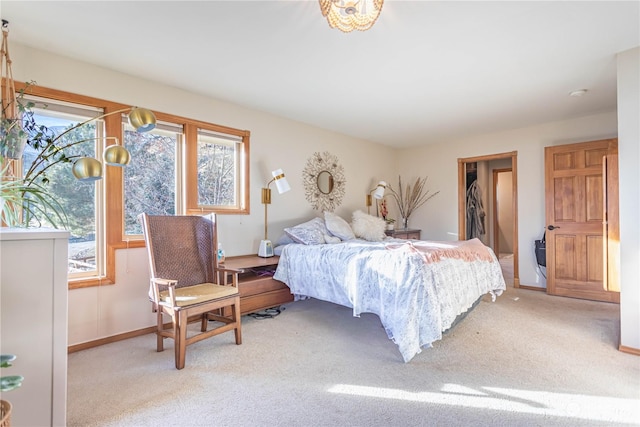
<box><xmin>140</xmin><ymin>214</ymin><xmax>242</xmax><ymax>369</ymax></box>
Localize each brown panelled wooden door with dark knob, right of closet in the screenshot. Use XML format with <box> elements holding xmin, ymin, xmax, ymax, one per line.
<box><xmin>545</xmin><ymin>139</ymin><xmax>620</xmax><ymax>302</ymax></box>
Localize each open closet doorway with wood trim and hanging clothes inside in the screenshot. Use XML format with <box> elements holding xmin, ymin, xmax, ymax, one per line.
<box><xmin>458</xmin><ymin>151</ymin><xmax>520</xmax><ymax>288</ymax></box>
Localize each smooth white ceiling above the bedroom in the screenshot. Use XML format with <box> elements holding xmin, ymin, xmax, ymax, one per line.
<box><xmin>0</xmin><ymin>0</ymin><xmax>640</xmax><ymax>147</ymax></box>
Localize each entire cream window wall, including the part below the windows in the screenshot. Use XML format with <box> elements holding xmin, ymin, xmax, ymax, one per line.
<box><xmin>11</xmin><ymin>44</ymin><xmax>396</xmax><ymax>345</ymax></box>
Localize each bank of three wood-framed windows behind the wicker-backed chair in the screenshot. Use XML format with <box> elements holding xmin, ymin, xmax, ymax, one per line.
<box><xmin>16</xmin><ymin>84</ymin><xmax>250</xmax><ymax>289</ymax></box>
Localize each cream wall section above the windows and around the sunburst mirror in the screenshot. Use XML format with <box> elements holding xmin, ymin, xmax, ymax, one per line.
<box><xmin>12</xmin><ymin>44</ymin><xmax>395</xmax><ymax>256</ymax></box>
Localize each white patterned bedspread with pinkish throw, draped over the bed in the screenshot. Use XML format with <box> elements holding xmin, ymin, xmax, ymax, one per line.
<box><xmin>274</xmin><ymin>239</ymin><xmax>506</xmax><ymax>362</ymax></box>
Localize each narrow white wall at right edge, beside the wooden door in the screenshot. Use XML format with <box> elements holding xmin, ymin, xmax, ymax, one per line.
<box><xmin>618</xmin><ymin>47</ymin><xmax>640</xmax><ymax>349</ymax></box>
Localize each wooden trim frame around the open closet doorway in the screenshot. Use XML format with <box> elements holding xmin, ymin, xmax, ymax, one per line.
<box><xmin>458</xmin><ymin>151</ymin><xmax>520</xmax><ymax>288</ymax></box>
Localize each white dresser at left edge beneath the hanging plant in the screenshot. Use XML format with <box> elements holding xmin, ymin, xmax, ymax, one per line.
<box><xmin>0</xmin><ymin>228</ymin><xmax>69</xmax><ymax>427</ymax></box>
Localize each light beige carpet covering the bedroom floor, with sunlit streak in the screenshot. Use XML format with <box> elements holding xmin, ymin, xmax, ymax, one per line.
<box><xmin>68</xmin><ymin>287</ymin><xmax>640</xmax><ymax>426</ymax></box>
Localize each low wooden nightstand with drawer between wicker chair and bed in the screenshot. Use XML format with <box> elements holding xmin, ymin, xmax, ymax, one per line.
<box><xmin>221</xmin><ymin>255</ymin><xmax>293</xmax><ymax>314</ymax></box>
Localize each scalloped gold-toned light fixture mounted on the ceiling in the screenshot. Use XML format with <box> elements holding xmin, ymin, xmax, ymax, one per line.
<box><xmin>319</xmin><ymin>0</ymin><xmax>384</xmax><ymax>33</ymax></box>
